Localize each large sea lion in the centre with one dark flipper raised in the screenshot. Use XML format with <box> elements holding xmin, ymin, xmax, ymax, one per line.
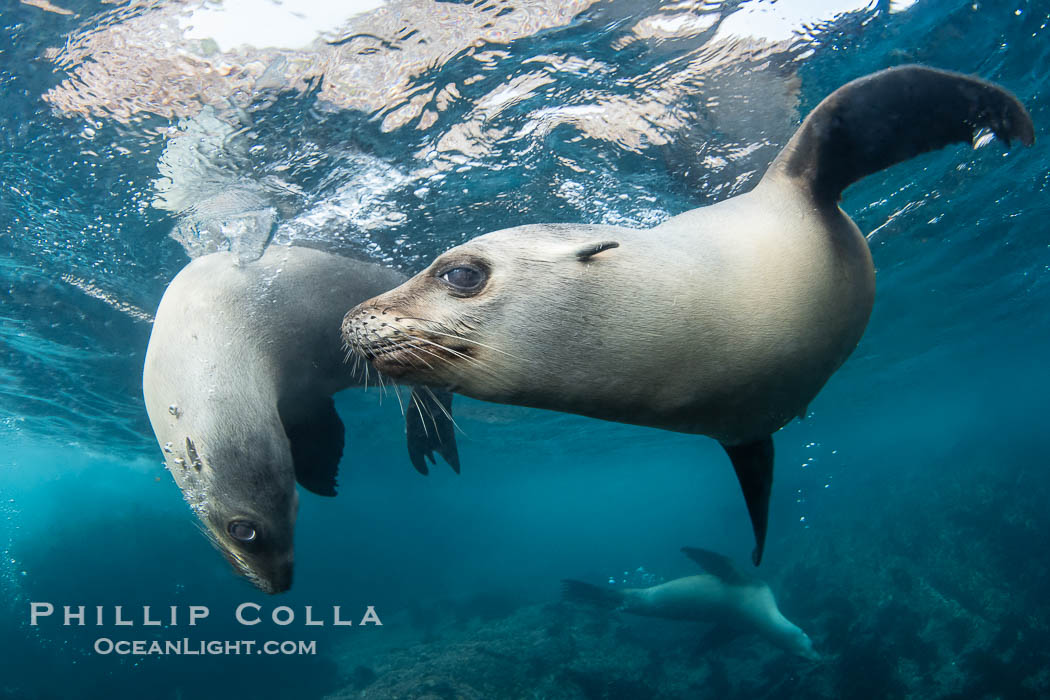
<box><xmin>342</xmin><ymin>66</ymin><xmax>1034</xmax><ymax>566</ymax></box>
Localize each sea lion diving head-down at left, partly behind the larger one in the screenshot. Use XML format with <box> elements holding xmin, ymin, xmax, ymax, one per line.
<box><xmin>143</xmin><ymin>246</ymin><xmax>459</xmax><ymax>593</ymax></box>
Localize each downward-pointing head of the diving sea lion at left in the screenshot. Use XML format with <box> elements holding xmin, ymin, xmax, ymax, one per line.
<box><xmin>165</xmin><ymin>416</ymin><xmax>299</xmax><ymax>593</ymax></box>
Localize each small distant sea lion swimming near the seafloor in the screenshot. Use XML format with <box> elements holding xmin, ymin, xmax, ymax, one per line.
<box><xmin>562</xmin><ymin>547</ymin><xmax>820</xmax><ymax>661</ymax></box>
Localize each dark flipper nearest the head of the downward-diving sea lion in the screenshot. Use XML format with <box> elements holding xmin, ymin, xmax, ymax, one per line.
<box><xmin>278</xmin><ymin>397</ymin><xmax>344</xmax><ymax>496</ymax></box>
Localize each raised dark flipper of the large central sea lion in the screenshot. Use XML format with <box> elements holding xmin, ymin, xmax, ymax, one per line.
<box><xmin>768</xmin><ymin>65</ymin><xmax>1035</xmax><ymax>204</ymax></box>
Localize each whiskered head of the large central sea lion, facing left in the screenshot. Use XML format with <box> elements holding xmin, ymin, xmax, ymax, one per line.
<box><xmin>342</xmin><ymin>226</ymin><xmax>620</xmax><ymax>405</ymax></box>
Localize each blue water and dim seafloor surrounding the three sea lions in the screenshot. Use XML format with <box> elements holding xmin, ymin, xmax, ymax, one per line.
<box><xmin>0</xmin><ymin>0</ymin><xmax>1050</xmax><ymax>698</ymax></box>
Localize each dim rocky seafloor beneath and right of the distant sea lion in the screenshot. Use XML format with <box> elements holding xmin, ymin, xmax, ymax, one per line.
<box><xmin>330</xmin><ymin>455</ymin><xmax>1050</xmax><ymax>700</ymax></box>
